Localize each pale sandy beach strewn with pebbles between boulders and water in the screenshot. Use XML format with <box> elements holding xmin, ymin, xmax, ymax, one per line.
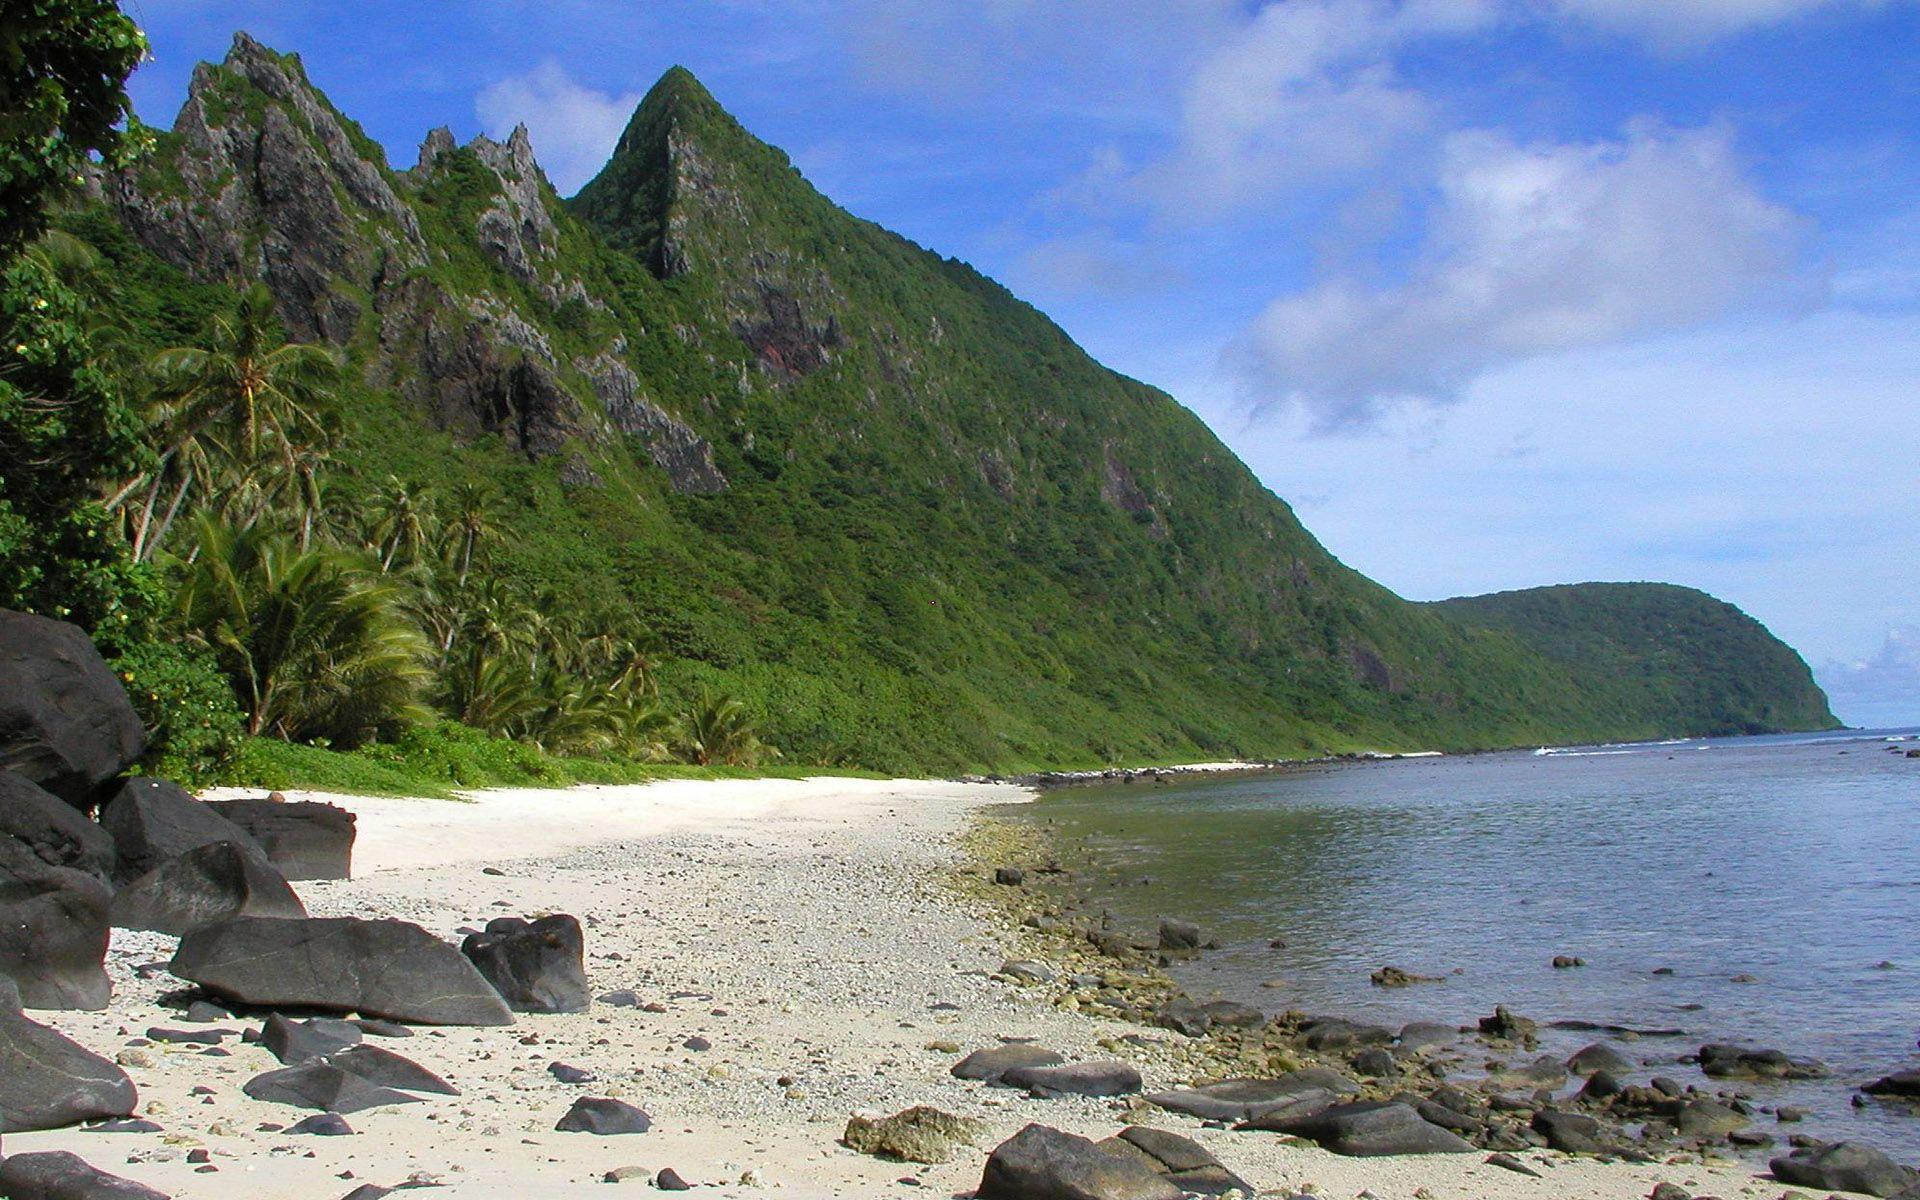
<box><xmin>6</xmin><ymin>780</ymin><xmax>1784</xmax><ymax>1200</ymax></box>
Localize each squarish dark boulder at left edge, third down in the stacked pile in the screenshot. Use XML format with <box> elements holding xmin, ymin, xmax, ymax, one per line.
<box><xmin>0</xmin><ymin>837</ymin><xmax>113</xmax><ymax>1010</ymax></box>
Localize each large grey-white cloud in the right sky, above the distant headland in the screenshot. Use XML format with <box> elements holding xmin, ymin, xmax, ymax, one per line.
<box><xmin>1229</xmin><ymin>123</ymin><xmax>1801</xmax><ymax>428</ymax></box>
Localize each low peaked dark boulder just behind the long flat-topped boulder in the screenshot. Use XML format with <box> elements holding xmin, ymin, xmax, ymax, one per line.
<box><xmin>111</xmin><ymin>841</ymin><xmax>307</xmax><ymax>937</ymax></box>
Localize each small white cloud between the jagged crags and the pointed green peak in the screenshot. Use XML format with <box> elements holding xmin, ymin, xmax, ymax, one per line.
<box><xmin>474</xmin><ymin>60</ymin><xmax>641</xmax><ymax>196</ymax></box>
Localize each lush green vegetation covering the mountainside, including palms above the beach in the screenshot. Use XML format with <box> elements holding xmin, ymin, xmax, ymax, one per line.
<box><xmin>0</xmin><ymin>18</ymin><xmax>1830</xmax><ymax>793</ymax></box>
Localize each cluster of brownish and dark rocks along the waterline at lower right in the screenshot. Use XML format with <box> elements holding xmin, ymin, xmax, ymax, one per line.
<box><xmin>975</xmin><ymin>833</ymin><xmax>1920</xmax><ymax>1200</ymax></box>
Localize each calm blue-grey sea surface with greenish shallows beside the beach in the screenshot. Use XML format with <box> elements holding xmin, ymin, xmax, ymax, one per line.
<box><xmin>1023</xmin><ymin>732</ymin><xmax>1920</xmax><ymax>1156</ymax></box>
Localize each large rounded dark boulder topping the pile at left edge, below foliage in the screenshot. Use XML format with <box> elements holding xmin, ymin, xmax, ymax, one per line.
<box><xmin>0</xmin><ymin>611</ymin><xmax>146</xmax><ymax>808</ymax></box>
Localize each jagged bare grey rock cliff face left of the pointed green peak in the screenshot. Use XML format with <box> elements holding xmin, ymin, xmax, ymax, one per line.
<box><xmin>100</xmin><ymin>33</ymin><xmax>726</xmax><ymax>492</ymax></box>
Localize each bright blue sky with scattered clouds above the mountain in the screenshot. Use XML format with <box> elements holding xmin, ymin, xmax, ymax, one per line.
<box><xmin>127</xmin><ymin>0</ymin><xmax>1920</xmax><ymax>726</ymax></box>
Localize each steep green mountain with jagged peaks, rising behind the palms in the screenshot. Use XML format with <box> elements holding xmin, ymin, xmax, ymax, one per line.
<box><xmin>69</xmin><ymin>35</ymin><xmax>1832</xmax><ymax>772</ymax></box>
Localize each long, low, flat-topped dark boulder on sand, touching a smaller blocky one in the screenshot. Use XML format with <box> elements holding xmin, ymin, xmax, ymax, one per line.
<box><xmin>171</xmin><ymin>916</ymin><xmax>513</xmax><ymax>1025</ymax></box>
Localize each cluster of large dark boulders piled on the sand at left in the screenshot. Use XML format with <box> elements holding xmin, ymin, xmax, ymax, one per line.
<box><xmin>0</xmin><ymin>612</ymin><xmax>618</xmax><ymax>1198</ymax></box>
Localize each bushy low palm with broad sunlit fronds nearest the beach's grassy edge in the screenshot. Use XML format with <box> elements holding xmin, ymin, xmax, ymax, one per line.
<box><xmin>175</xmin><ymin>515</ymin><xmax>428</xmax><ymax>745</ymax></box>
